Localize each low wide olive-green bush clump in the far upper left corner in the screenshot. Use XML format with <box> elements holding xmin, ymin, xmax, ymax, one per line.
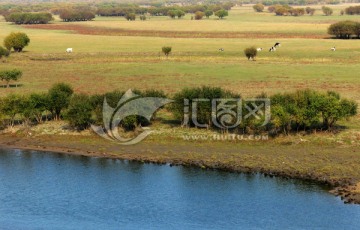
<box><xmin>5</xmin><ymin>13</ymin><xmax>54</xmax><ymax>24</ymax></box>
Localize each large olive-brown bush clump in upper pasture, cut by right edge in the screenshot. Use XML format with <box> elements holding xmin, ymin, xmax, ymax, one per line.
<box><xmin>328</xmin><ymin>21</ymin><xmax>360</xmax><ymax>39</ymax></box>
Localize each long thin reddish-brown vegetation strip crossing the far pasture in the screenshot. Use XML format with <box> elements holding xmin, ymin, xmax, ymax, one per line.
<box><xmin>24</xmin><ymin>24</ymin><xmax>327</xmax><ymax>39</ymax></box>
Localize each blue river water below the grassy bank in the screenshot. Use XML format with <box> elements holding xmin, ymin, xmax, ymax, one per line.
<box><xmin>0</xmin><ymin>150</ymin><xmax>360</xmax><ymax>230</ymax></box>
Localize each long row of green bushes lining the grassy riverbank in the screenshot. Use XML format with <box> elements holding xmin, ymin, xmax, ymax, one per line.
<box><xmin>0</xmin><ymin>83</ymin><xmax>357</xmax><ymax>134</ymax></box>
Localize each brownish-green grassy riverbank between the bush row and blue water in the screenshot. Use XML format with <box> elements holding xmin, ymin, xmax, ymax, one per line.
<box><xmin>0</xmin><ymin>127</ymin><xmax>360</xmax><ymax>204</ymax></box>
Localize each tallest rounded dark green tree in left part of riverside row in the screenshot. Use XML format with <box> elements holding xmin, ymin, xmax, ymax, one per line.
<box><xmin>47</xmin><ymin>83</ymin><xmax>74</xmax><ymax>120</ymax></box>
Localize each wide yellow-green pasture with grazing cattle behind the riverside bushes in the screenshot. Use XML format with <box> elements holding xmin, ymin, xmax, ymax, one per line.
<box><xmin>0</xmin><ymin>5</ymin><xmax>360</xmax><ymax>126</ymax></box>
